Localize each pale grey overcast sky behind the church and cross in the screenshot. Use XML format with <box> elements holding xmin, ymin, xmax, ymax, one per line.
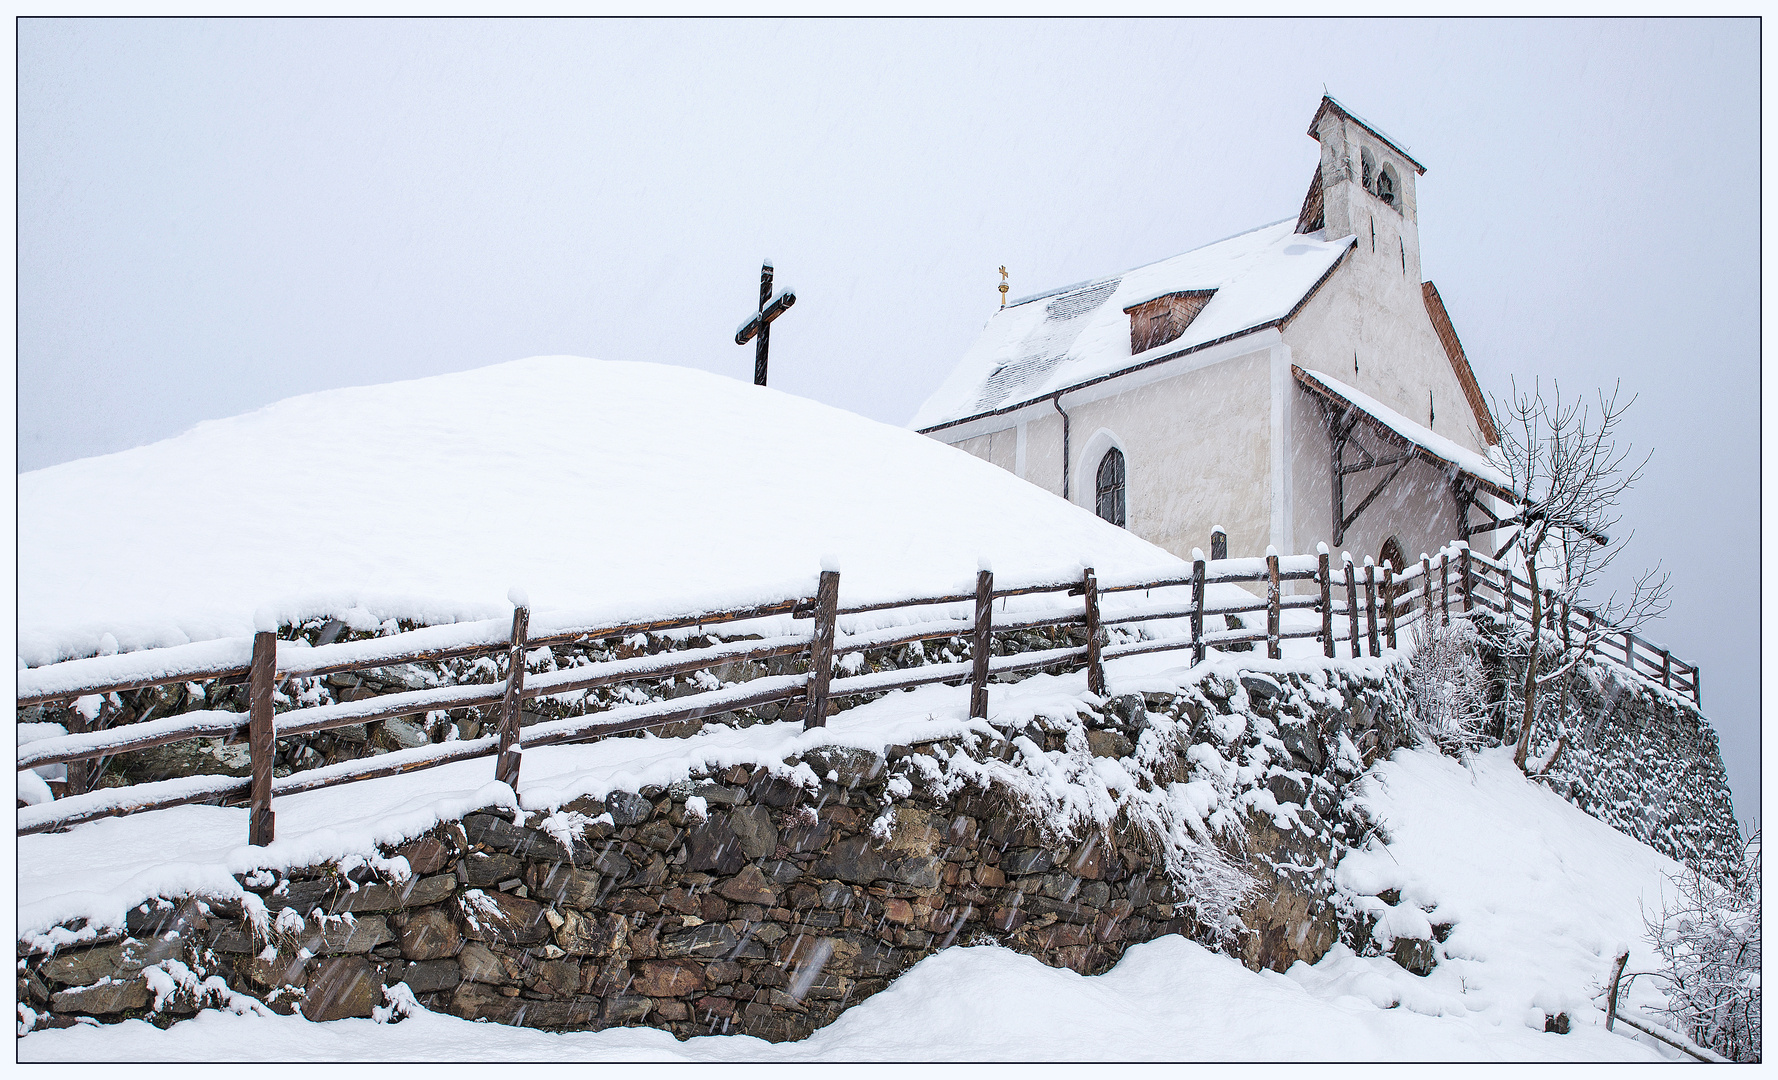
<box><xmin>18</xmin><ymin>20</ymin><xmax>1760</xmax><ymax>820</ymax></box>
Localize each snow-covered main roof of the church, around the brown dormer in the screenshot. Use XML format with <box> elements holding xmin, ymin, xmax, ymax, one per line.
<box><xmin>909</xmin><ymin>219</ymin><xmax>1357</xmax><ymax>431</ymax></box>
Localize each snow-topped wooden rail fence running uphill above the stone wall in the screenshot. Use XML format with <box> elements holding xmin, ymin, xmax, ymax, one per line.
<box><xmin>18</xmin><ymin>543</ymin><xmax>1700</xmax><ymax>845</ymax></box>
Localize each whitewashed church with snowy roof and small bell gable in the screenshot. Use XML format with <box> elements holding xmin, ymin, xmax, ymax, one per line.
<box><xmin>910</xmin><ymin>98</ymin><xmax>1510</xmax><ymax>568</ymax></box>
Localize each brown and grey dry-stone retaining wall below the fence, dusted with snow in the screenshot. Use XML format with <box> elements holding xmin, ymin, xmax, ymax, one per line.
<box><xmin>20</xmin><ymin>661</ymin><xmax>1405</xmax><ymax>1039</ymax></box>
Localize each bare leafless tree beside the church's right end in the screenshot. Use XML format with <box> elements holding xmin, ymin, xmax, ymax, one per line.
<box><xmin>1494</xmin><ymin>383</ymin><xmax>1668</xmax><ymax>769</ymax></box>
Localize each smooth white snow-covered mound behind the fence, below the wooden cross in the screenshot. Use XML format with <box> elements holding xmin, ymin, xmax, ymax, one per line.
<box><xmin>18</xmin><ymin>356</ymin><xmax>1179</xmax><ymax>665</ymax></box>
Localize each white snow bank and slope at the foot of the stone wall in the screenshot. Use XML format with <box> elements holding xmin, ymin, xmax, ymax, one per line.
<box><xmin>20</xmin><ymin>751</ymin><xmax>1699</xmax><ymax>1062</ymax></box>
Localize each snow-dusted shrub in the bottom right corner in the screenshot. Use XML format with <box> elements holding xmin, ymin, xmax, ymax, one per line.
<box><xmin>1645</xmin><ymin>833</ymin><xmax>1760</xmax><ymax>1060</ymax></box>
